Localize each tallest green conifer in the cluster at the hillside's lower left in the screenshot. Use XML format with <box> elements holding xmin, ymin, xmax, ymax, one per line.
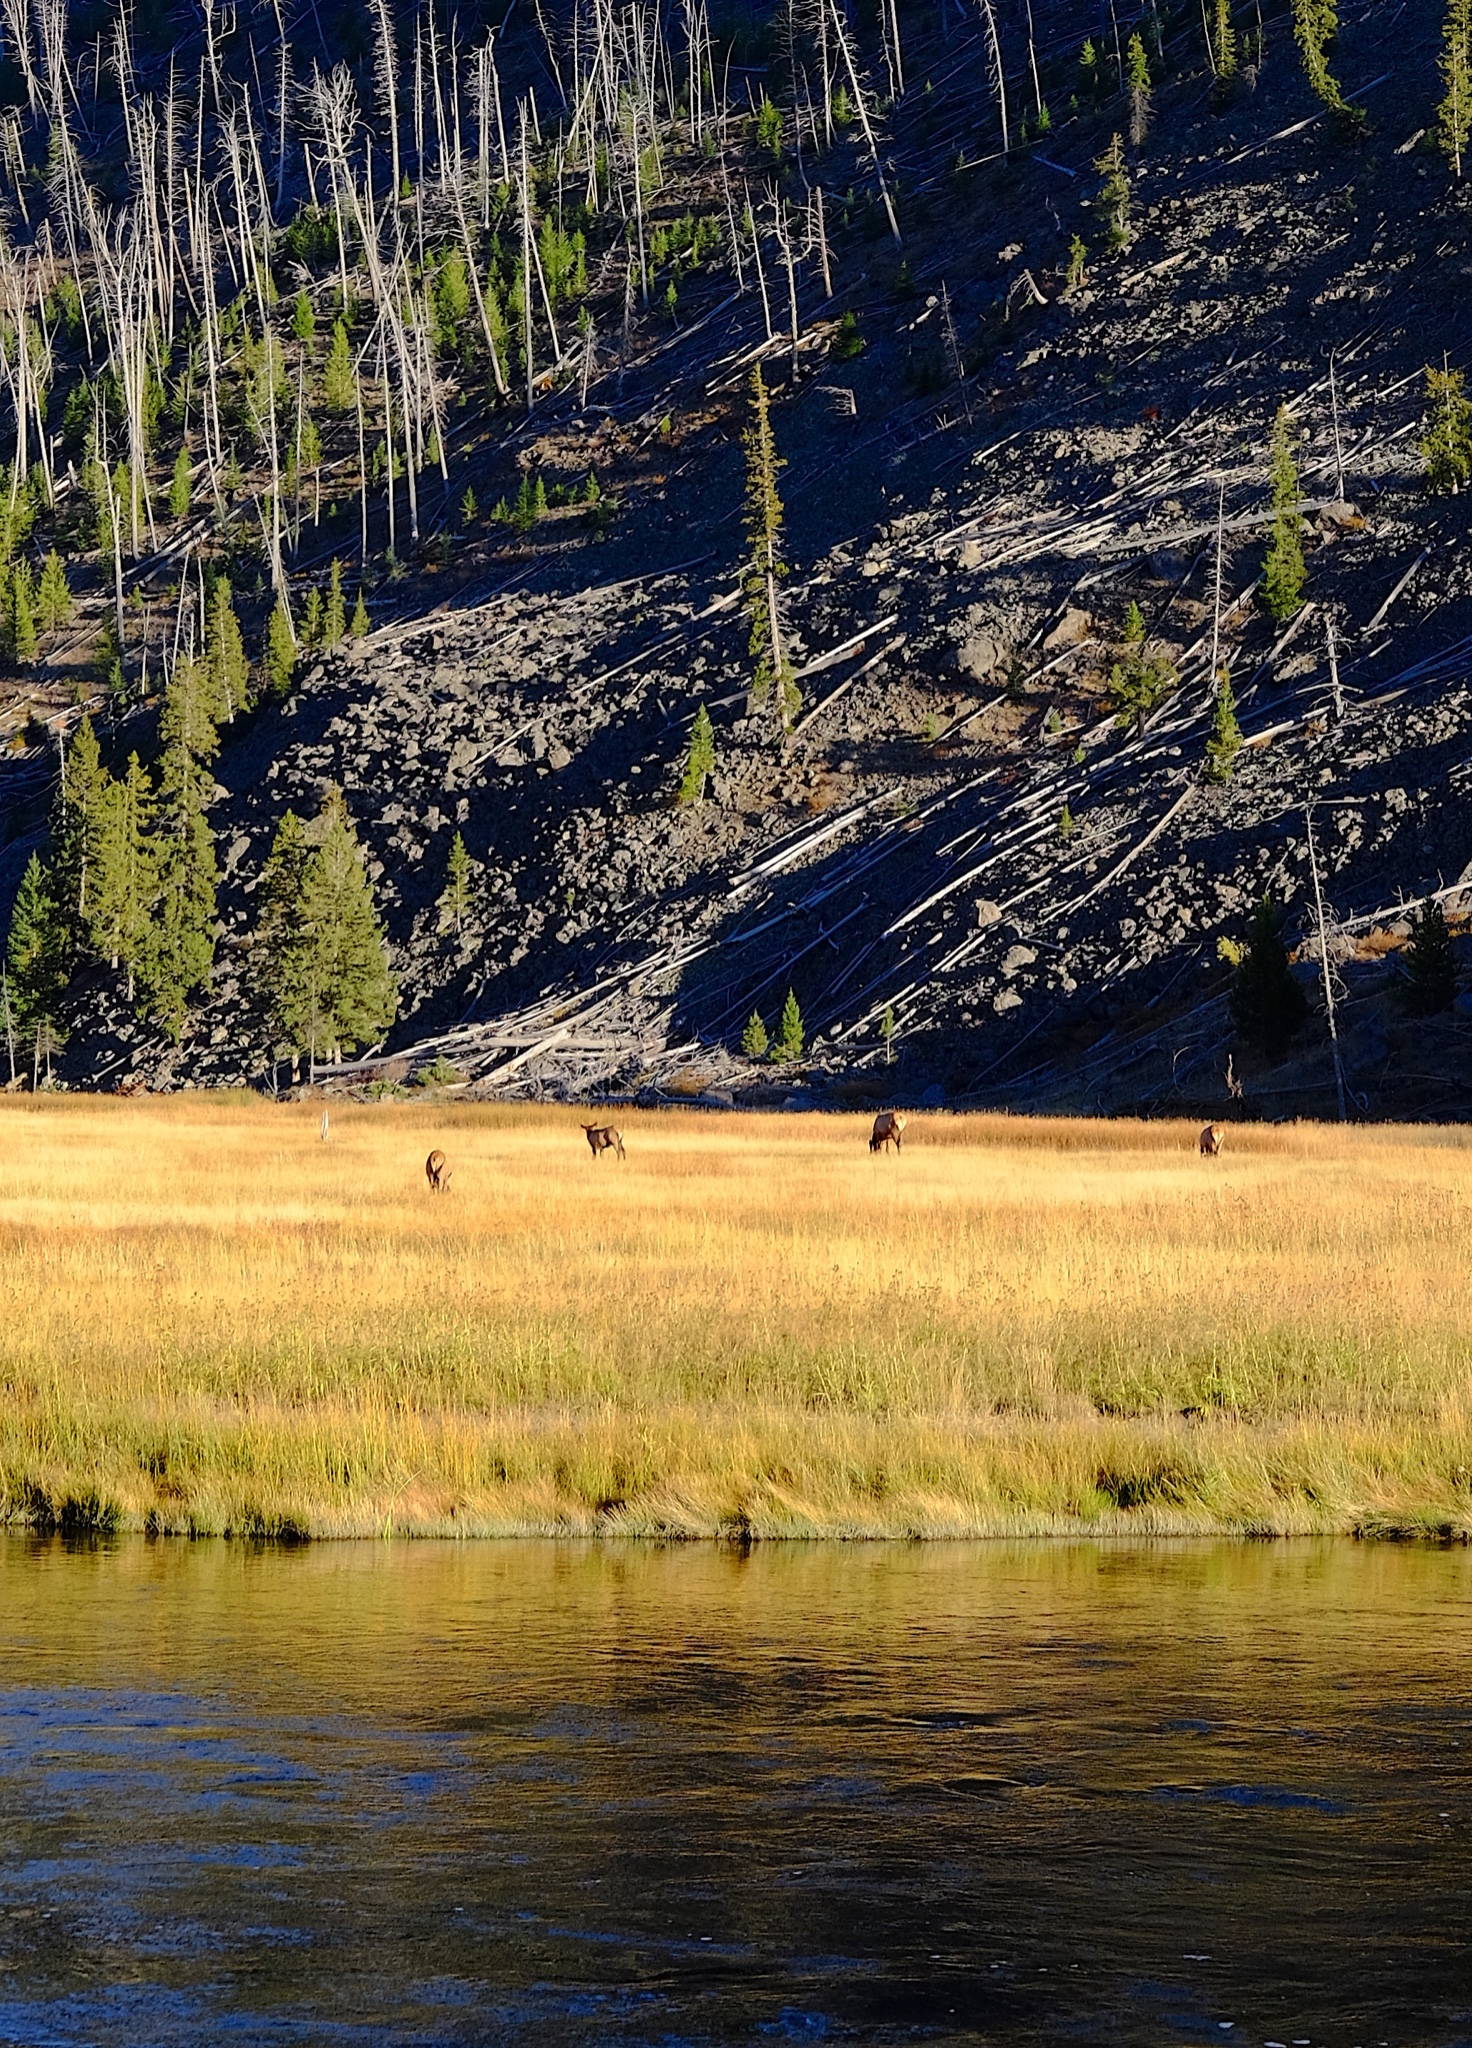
<box><xmin>139</xmin><ymin>659</ymin><xmax>222</xmax><ymax>1038</ymax></box>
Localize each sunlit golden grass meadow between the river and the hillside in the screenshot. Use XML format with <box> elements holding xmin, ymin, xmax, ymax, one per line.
<box><xmin>0</xmin><ymin>1094</ymin><xmax>1472</xmax><ymax>1538</ymax></box>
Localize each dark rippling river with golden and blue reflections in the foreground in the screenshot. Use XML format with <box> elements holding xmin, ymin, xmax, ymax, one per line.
<box><xmin>0</xmin><ymin>1536</ymin><xmax>1472</xmax><ymax>2048</ymax></box>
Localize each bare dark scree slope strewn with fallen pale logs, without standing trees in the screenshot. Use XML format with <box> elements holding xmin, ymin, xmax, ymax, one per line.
<box><xmin>0</xmin><ymin>0</ymin><xmax>1472</xmax><ymax>1114</ymax></box>
